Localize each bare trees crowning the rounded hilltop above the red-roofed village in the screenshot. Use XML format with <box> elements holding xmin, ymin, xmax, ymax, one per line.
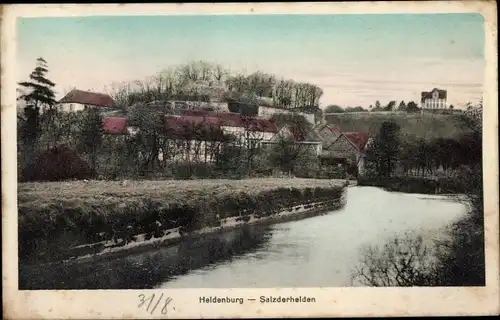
<box><xmin>99</xmin><ymin>61</ymin><xmax>323</xmax><ymax>113</ymax></box>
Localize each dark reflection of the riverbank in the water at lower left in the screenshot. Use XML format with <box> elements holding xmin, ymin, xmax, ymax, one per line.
<box><xmin>19</xmin><ymin>226</ymin><xmax>271</xmax><ymax>290</ymax></box>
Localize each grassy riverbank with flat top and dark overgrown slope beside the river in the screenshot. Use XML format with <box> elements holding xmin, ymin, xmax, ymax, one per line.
<box><xmin>18</xmin><ymin>179</ymin><xmax>345</xmax><ymax>263</ymax></box>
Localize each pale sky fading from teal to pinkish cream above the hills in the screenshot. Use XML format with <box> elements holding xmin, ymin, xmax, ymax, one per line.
<box><xmin>17</xmin><ymin>14</ymin><xmax>485</xmax><ymax>107</ymax></box>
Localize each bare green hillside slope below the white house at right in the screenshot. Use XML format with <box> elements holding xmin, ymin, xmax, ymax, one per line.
<box><xmin>325</xmin><ymin>112</ymin><xmax>462</xmax><ymax>139</ymax></box>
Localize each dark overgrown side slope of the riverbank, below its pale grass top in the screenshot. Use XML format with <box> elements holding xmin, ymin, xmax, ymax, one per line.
<box><xmin>19</xmin><ymin>187</ymin><xmax>343</xmax><ymax>260</ymax></box>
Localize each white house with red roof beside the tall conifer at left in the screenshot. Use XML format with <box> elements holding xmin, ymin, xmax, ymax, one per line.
<box><xmin>57</xmin><ymin>89</ymin><xmax>116</xmax><ymax>112</ymax></box>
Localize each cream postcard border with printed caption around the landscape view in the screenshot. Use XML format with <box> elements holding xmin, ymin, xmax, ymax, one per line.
<box><xmin>1</xmin><ymin>1</ymin><xmax>500</xmax><ymax>319</ymax></box>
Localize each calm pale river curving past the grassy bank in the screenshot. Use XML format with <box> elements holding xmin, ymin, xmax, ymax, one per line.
<box><xmin>19</xmin><ymin>187</ymin><xmax>465</xmax><ymax>289</ymax></box>
